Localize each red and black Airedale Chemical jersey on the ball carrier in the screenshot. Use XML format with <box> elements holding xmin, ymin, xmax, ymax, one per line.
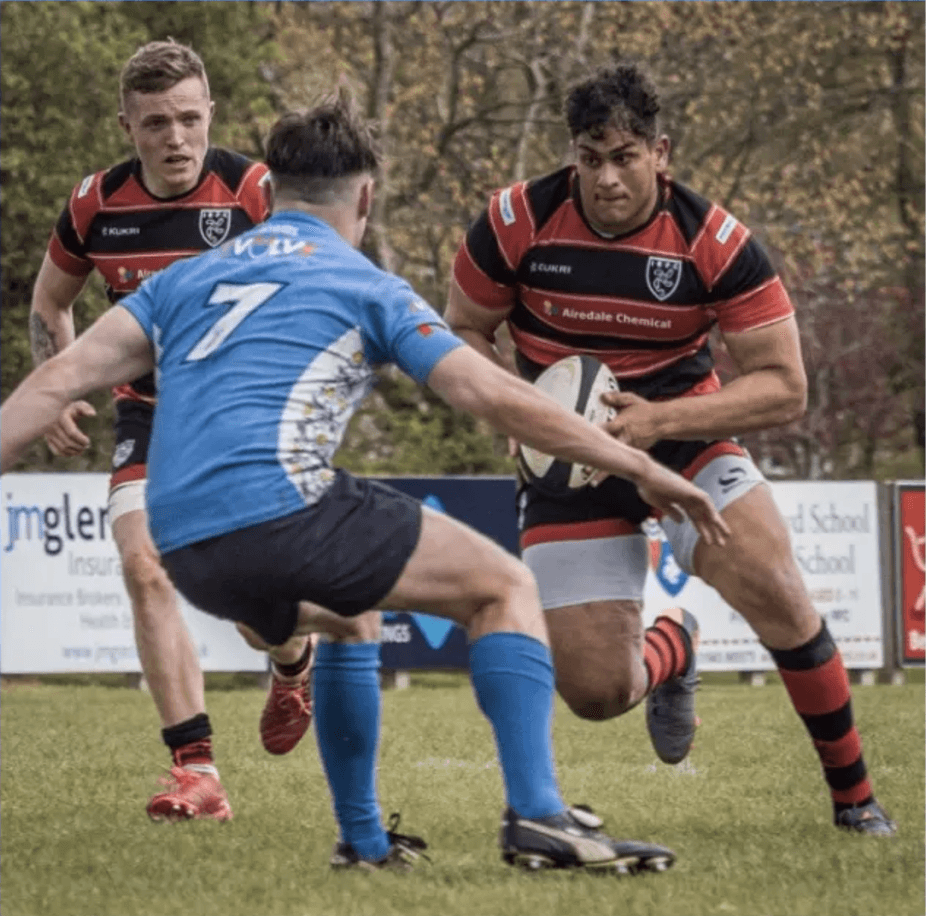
<box><xmin>454</xmin><ymin>166</ymin><xmax>794</xmax><ymax>398</ymax></box>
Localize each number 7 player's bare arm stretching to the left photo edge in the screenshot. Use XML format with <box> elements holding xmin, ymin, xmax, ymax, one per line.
<box><xmin>0</xmin><ymin>306</ymin><xmax>154</xmax><ymax>472</ymax></box>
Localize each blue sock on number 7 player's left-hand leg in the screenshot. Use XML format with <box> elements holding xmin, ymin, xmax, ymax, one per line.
<box><xmin>312</xmin><ymin>642</ymin><xmax>389</xmax><ymax>861</ymax></box>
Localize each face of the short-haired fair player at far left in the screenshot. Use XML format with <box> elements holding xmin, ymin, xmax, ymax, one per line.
<box><xmin>119</xmin><ymin>76</ymin><xmax>213</xmax><ymax>197</ymax></box>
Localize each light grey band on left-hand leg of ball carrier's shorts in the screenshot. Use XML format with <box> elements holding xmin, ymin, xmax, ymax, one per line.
<box><xmin>521</xmin><ymin>533</ymin><xmax>649</xmax><ymax>610</ymax></box>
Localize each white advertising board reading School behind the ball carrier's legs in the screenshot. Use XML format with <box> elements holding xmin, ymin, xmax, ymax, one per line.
<box><xmin>644</xmin><ymin>481</ymin><xmax>884</xmax><ymax>671</ymax></box>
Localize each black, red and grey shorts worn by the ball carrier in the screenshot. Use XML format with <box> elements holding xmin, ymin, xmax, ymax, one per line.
<box><xmin>519</xmin><ymin>442</ymin><xmax>765</xmax><ymax>609</ymax></box>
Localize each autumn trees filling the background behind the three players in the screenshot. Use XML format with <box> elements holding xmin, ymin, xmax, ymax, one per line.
<box><xmin>0</xmin><ymin>2</ymin><xmax>924</xmax><ymax>477</ymax></box>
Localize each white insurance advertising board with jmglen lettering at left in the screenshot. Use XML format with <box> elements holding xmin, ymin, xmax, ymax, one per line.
<box><xmin>0</xmin><ymin>474</ymin><xmax>267</xmax><ymax>674</ymax></box>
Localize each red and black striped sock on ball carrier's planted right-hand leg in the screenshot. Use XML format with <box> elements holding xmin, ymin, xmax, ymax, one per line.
<box><xmin>768</xmin><ymin>622</ymin><xmax>872</xmax><ymax>812</ymax></box>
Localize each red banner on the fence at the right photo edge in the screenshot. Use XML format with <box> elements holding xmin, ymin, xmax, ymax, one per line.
<box><xmin>892</xmin><ymin>481</ymin><xmax>926</xmax><ymax>665</ymax></box>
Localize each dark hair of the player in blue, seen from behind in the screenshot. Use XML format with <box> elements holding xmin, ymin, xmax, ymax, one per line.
<box><xmin>266</xmin><ymin>87</ymin><xmax>381</xmax><ymax>203</ymax></box>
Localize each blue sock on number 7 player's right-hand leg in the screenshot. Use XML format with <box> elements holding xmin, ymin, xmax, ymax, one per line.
<box><xmin>469</xmin><ymin>633</ymin><xmax>566</xmax><ymax>818</ymax></box>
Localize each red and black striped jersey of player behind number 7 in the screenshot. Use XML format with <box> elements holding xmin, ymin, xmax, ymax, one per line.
<box><xmin>48</xmin><ymin>147</ymin><xmax>270</xmax><ymax>403</ymax></box>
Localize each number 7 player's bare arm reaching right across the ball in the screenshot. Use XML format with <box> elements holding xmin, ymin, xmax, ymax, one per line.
<box><xmin>428</xmin><ymin>347</ymin><xmax>730</xmax><ymax>544</ymax></box>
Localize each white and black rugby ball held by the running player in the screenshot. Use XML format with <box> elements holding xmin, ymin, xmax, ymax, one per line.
<box><xmin>518</xmin><ymin>356</ymin><xmax>618</xmax><ymax>496</ymax></box>
